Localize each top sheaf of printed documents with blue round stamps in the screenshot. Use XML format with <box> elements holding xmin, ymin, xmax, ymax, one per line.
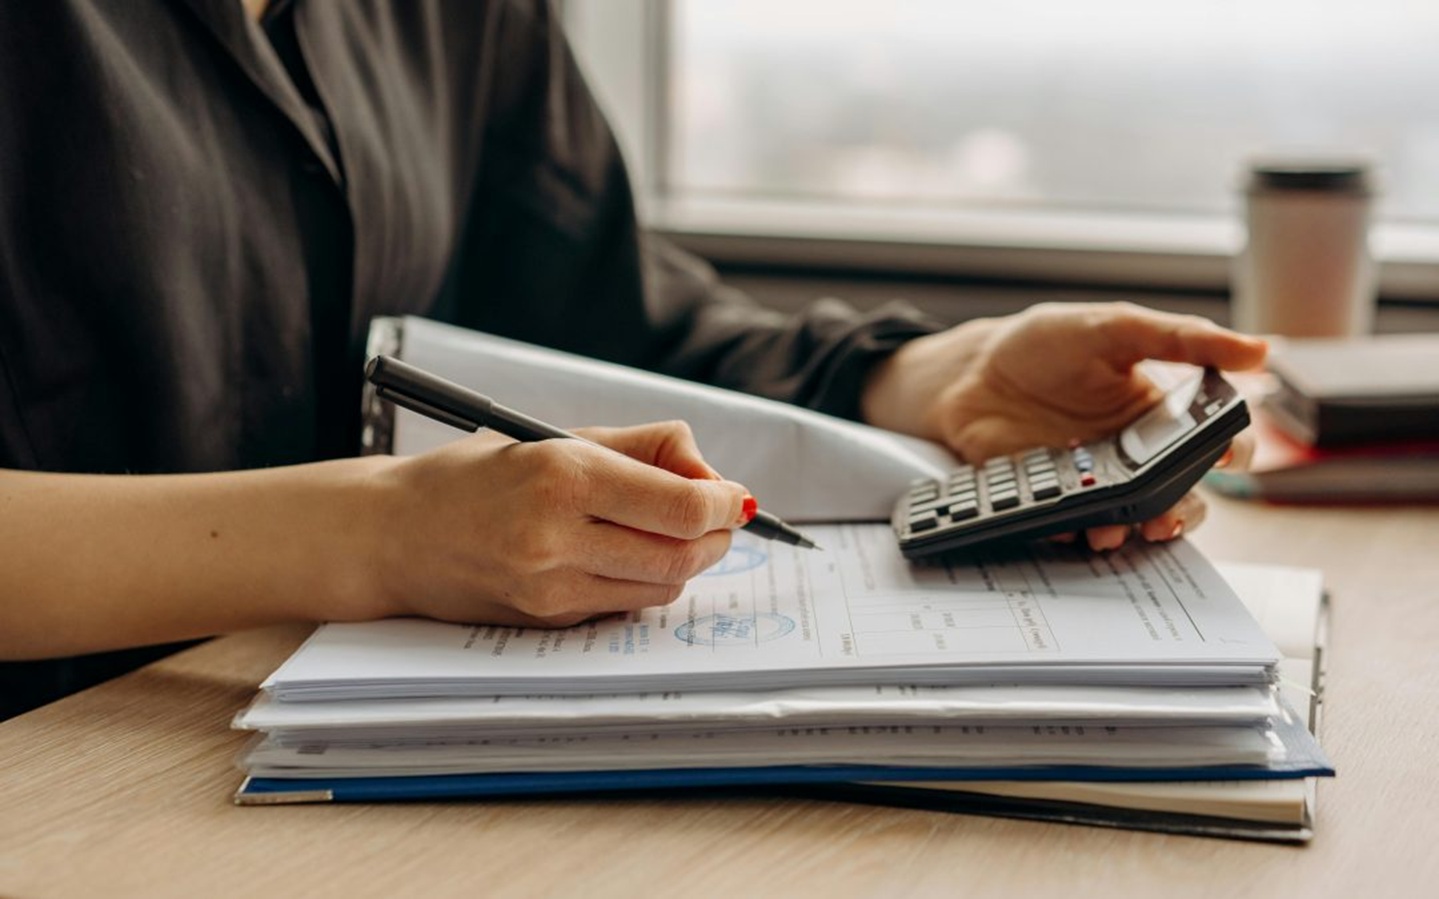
<box><xmin>263</xmin><ymin>524</ymin><xmax>1281</xmax><ymax>701</ymax></box>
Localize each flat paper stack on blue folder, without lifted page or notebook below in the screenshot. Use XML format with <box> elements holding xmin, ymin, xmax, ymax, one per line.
<box><xmin>236</xmin><ymin>525</ymin><xmax>1331</xmax><ymax>840</ymax></box>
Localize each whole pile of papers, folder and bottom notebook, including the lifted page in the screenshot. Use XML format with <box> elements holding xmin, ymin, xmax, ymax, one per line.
<box><xmin>235</xmin><ymin>319</ymin><xmax>1333</xmax><ymax>840</ymax></box>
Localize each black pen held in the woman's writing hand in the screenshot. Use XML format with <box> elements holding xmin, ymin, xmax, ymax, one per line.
<box><xmin>364</xmin><ymin>355</ymin><xmax>819</xmax><ymax>549</ymax></box>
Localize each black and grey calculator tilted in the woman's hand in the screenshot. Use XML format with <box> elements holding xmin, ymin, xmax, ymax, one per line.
<box><xmin>891</xmin><ymin>368</ymin><xmax>1249</xmax><ymax>558</ymax></box>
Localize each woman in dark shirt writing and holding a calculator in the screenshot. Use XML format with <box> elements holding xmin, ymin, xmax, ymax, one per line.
<box><xmin>0</xmin><ymin>0</ymin><xmax>1263</xmax><ymax>713</ymax></box>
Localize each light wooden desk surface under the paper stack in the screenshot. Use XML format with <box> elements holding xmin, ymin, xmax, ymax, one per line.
<box><xmin>0</xmin><ymin>501</ymin><xmax>1439</xmax><ymax>899</ymax></box>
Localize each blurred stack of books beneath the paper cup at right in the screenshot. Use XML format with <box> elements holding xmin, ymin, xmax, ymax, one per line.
<box><xmin>1209</xmin><ymin>334</ymin><xmax>1439</xmax><ymax>502</ymax></box>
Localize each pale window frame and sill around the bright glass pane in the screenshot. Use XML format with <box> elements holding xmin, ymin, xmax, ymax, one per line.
<box><xmin>563</xmin><ymin>0</ymin><xmax>1439</xmax><ymax>304</ymax></box>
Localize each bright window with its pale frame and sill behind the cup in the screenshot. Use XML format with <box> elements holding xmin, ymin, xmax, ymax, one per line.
<box><xmin>570</xmin><ymin>0</ymin><xmax>1439</xmax><ymax>296</ymax></box>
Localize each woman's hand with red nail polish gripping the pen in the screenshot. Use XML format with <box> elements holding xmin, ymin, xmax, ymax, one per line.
<box><xmin>362</xmin><ymin>421</ymin><xmax>754</xmax><ymax>627</ymax></box>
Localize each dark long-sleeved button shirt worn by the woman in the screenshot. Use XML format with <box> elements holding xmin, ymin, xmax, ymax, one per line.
<box><xmin>0</xmin><ymin>0</ymin><xmax>931</xmax><ymax>716</ymax></box>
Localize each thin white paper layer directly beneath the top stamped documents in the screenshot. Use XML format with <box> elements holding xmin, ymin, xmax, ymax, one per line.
<box><xmin>235</xmin><ymin>686</ymin><xmax>1279</xmax><ymax>742</ymax></box>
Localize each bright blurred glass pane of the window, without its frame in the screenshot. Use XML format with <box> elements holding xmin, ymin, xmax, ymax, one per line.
<box><xmin>663</xmin><ymin>0</ymin><xmax>1439</xmax><ymax>222</ymax></box>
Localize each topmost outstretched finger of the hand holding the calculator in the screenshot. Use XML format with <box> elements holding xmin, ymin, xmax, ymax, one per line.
<box><xmin>1099</xmin><ymin>304</ymin><xmax>1268</xmax><ymax>370</ymax></box>
